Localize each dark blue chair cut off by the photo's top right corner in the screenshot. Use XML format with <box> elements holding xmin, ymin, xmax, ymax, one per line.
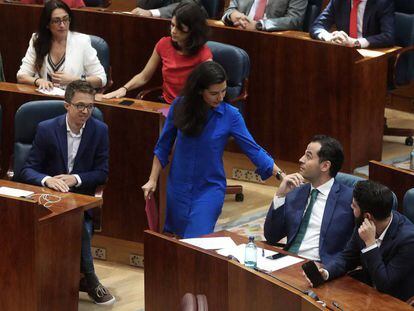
<box><xmin>384</xmin><ymin>0</ymin><xmax>414</xmax><ymax>146</ymax></box>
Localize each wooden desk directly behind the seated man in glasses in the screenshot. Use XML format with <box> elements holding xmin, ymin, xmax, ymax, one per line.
<box><xmin>0</xmin><ymin>82</ymin><xmax>168</xmax><ymax>246</ymax></box>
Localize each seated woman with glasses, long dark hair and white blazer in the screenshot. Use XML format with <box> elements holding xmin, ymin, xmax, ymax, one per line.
<box><xmin>17</xmin><ymin>0</ymin><xmax>106</xmax><ymax>89</ymax></box>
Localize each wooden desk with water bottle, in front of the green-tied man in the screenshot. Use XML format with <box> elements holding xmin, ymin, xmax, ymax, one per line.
<box><xmin>144</xmin><ymin>231</ymin><xmax>412</xmax><ymax>311</ymax></box>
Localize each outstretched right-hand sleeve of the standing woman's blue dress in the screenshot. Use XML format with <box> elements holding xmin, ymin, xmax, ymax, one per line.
<box><xmin>230</xmin><ymin>111</ymin><xmax>274</xmax><ymax>180</ymax></box>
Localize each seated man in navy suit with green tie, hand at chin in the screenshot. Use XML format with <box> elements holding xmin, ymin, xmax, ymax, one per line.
<box><xmin>264</xmin><ymin>135</ymin><xmax>354</xmax><ymax>262</ymax></box>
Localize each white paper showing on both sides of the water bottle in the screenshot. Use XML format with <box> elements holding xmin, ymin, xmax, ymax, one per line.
<box><xmin>217</xmin><ymin>244</ymin><xmax>303</xmax><ymax>272</ymax></box>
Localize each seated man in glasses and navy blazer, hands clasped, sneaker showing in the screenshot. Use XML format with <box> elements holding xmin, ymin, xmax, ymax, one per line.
<box><xmin>17</xmin><ymin>80</ymin><xmax>115</xmax><ymax>304</ymax></box>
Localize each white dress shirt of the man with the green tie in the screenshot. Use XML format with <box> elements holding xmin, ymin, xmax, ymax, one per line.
<box><xmin>273</xmin><ymin>178</ymin><xmax>335</xmax><ymax>261</ymax></box>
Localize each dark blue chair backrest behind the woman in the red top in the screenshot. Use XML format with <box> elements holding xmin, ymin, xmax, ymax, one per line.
<box><xmin>207</xmin><ymin>41</ymin><xmax>250</xmax><ymax>112</ymax></box>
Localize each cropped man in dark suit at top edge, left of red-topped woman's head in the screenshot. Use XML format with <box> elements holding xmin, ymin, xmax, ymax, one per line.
<box><xmin>131</xmin><ymin>0</ymin><xmax>203</xmax><ymax>18</ymax></box>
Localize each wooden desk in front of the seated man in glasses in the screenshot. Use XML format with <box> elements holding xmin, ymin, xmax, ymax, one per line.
<box><xmin>0</xmin><ymin>180</ymin><xmax>102</xmax><ymax>311</ymax></box>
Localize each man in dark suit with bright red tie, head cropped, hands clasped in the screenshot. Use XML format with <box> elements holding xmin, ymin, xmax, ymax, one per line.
<box><xmin>310</xmin><ymin>0</ymin><xmax>395</xmax><ymax>48</ymax></box>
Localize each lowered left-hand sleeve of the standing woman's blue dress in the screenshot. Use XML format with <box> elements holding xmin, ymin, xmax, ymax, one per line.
<box><xmin>154</xmin><ymin>99</ymin><xmax>177</xmax><ymax>168</ymax></box>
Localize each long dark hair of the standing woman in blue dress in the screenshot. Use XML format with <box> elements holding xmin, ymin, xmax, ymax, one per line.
<box><xmin>174</xmin><ymin>61</ymin><xmax>227</xmax><ymax>136</ymax></box>
